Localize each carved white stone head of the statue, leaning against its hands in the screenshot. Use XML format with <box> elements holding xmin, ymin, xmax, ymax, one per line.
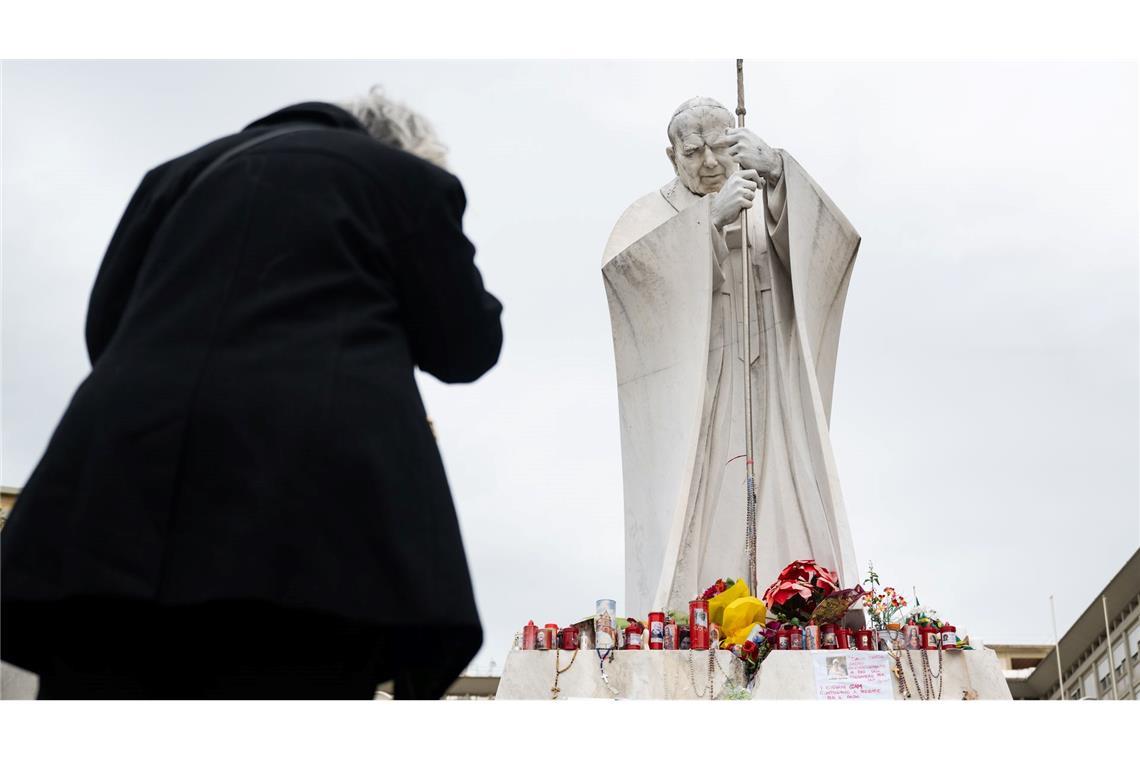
<box><xmin>665</xmin><ymin>98</ymin><xmax>736</xmax><ymax>195</ymax></box>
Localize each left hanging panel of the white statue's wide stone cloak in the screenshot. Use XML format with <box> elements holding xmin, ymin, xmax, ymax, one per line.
<box><xmin>602</xmin><ymin>201</ymin><xmax>714</xmax><ymax>610</ymax></box>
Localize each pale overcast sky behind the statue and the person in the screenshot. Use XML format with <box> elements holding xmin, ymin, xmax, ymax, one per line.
<box><xmin>0</xmin><ymin>59</ymin><xmax>1140</xmax><ymax>668</ymax></box>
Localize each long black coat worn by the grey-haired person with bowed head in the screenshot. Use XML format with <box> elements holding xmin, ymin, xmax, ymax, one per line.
<box><xmin>0</xmin><ymin>103</ymin><xmax>503</xmax><ymax>688</ymax></box>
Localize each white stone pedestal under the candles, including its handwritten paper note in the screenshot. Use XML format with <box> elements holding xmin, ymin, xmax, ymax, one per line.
<box><xmin>496</xmin><ymin>648</ymin><xmax>1012</xmax><ymax>700</ymax></box>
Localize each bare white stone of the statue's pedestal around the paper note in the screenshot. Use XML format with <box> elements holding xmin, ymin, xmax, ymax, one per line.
<box><xmin>496</xmin><ymin>648</ymin><xmax>1012</xmax><ymax>700</ymax></box>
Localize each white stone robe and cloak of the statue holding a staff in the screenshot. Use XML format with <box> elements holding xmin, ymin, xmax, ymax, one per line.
<box><xmin>602</xmin><ymin>154</ymin><xmax>860</xmax><ymax>613</ymax></box>
